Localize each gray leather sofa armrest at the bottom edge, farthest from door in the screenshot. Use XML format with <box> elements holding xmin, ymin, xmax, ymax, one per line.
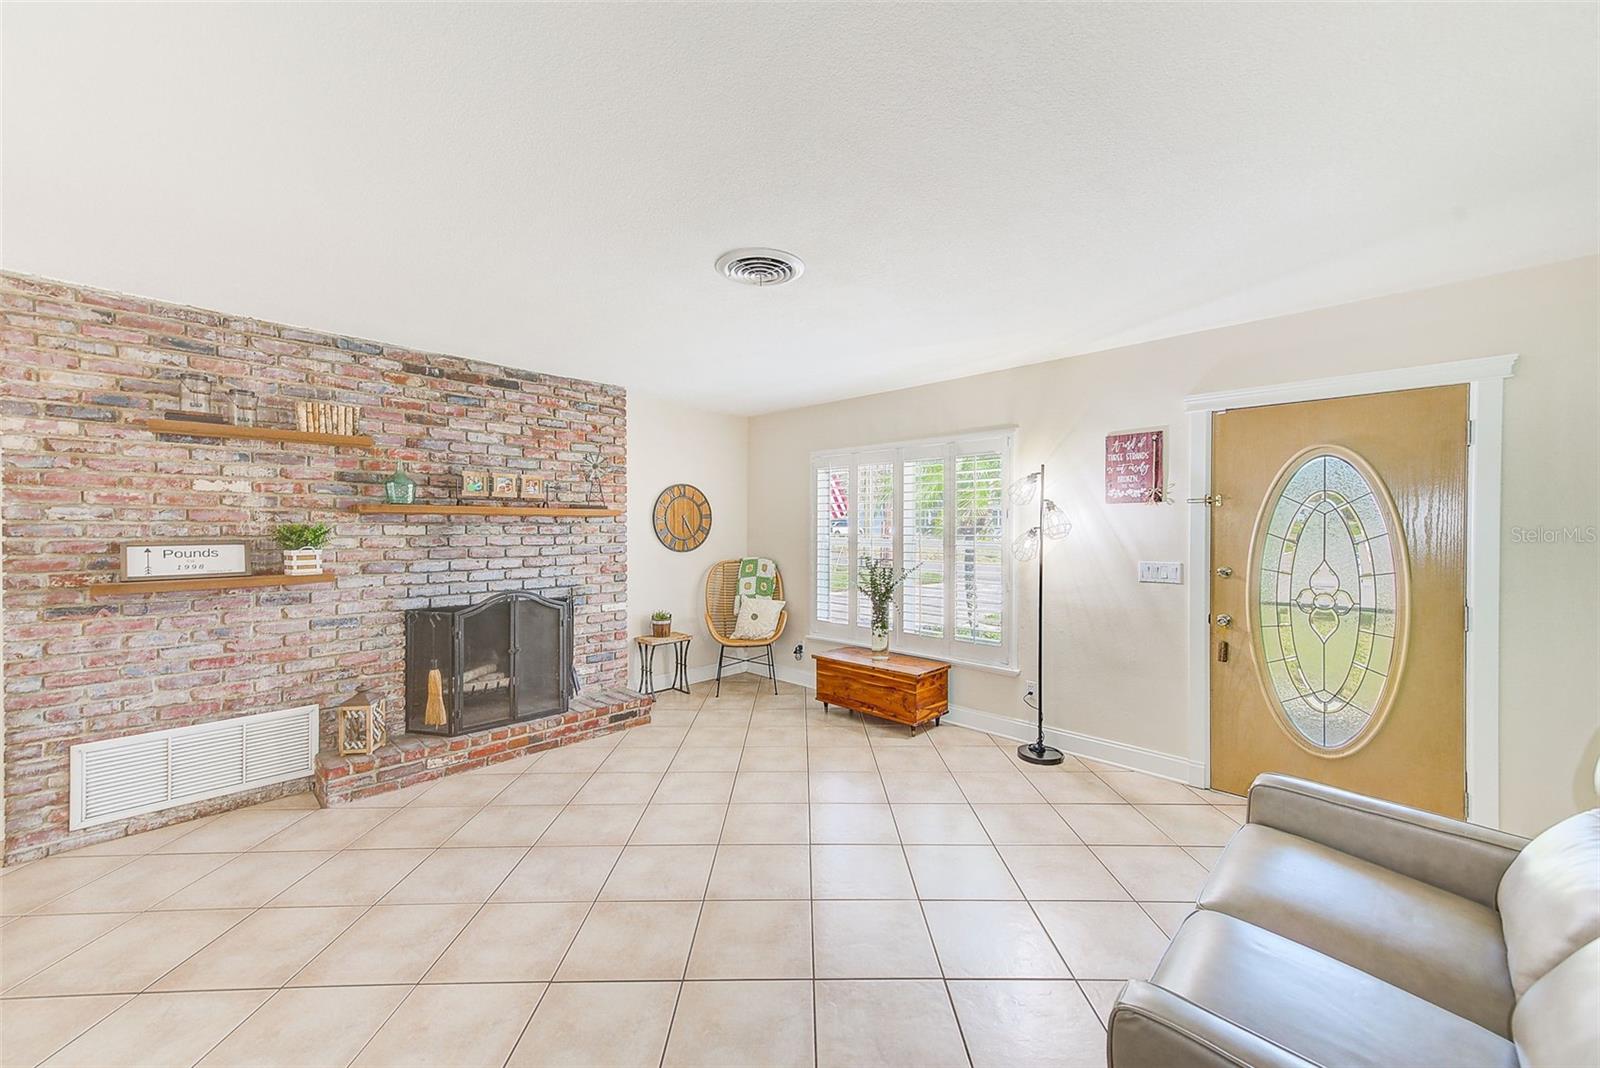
<box><xmin>1106</xmin><ymin>980</ymin><xmax>1315</xmax><ymax>1068</ymax></box>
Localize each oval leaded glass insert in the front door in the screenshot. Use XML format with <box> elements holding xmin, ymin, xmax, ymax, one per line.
<box><xmin>1251</xmin><ymin>446</ymin><xmax>1406</xmax><ymax>755</ymax></box>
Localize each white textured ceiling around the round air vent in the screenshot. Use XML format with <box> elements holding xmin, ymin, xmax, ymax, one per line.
<box><xmin>0</xmin><ymin>3</ymin><xmax>1597</xmax><ymax>412</ymax></box>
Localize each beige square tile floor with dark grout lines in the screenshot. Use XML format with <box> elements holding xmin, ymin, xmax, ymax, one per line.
<box><xmin>0</xmin><ymin>678</ymin><xmax>1243</xmax><ymax>1068</ymax></box>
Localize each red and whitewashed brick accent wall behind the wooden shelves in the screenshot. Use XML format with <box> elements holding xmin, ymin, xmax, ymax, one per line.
<box><xmin>0</xmin><ymin>273</ymin><xmax>627</xmax><ymax>863</ymax></box>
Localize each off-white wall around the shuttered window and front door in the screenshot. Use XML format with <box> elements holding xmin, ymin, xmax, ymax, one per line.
<box><xmin>745</xmin><ymin>257</ymin><xmax>1600</xmax><ymax>833</ymax></box>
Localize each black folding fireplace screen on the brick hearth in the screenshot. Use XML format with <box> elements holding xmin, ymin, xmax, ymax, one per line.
<box><xmin>405</xmin><ymin>592</ymin><xmax>573</xmax><ymax>734</ymax></box>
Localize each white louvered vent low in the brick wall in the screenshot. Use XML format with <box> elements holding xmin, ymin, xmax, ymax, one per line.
<box><xmin>70</xmin><ymin>705</ymin><xmax>317</xmax><ymax>830</ymax></box>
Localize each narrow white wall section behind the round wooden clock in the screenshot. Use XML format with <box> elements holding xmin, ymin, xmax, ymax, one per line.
<box><xmin>627</xmin><ymin>390</ymin><xmax>749</xmax><ymax>686</ymax></box>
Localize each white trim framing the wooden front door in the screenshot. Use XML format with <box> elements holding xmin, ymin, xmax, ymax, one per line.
<box><xmin>1184</xmin><ymin>353</ymin><xmax>1517</xmax><ymax>827</ymax></box>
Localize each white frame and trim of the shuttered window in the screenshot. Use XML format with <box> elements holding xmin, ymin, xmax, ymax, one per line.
<box><xmin>806</xmin><ymin>427</ymin><xmax>1021</xmax><ymax>675</ymax></box>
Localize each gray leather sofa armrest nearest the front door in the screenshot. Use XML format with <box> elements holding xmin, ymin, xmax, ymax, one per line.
<box><xmin>1248</xmin><ymin>775</ymin><xmax>1528</xmax><ymax>908</ymax></box>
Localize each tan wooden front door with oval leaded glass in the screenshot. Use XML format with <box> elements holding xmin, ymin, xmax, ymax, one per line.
<box><xmin>1210</xmin><ymin>385</ymin><xmax>1469</xmax><ymax>817</ymax></box>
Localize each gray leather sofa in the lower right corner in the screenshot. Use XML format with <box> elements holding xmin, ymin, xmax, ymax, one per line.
<box><xmin>1106</xmin><ymin>775</ymin><xmax>1600</xmax><ymax>1068</ymax></box>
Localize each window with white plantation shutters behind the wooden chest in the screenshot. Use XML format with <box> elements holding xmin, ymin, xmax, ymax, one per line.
<box><xmin>811</xmin><ymin>433</ymin><xmax>1014</xmax><ymax>667</ymax></box>
